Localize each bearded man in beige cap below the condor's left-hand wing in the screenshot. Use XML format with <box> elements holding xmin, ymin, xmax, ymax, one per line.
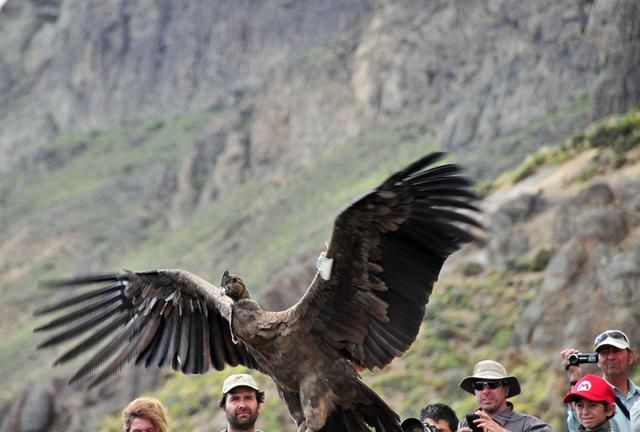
<box><xmin>218</xmin><ymin>374</ymin><xmax>264</xmax><ymax>432</ymax></box>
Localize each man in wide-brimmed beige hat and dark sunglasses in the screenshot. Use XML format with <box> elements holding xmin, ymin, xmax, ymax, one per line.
<box><xmin>458</xmin><ymin>360</ymin><xmax>551</xmax><ymax>432</ymax></box>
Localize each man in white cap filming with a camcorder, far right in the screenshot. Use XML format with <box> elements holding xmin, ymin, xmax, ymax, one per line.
<box><xmin>560</xmin><ymin>330</ymin><xmax>640</xmax><ymax>432</ymax></box>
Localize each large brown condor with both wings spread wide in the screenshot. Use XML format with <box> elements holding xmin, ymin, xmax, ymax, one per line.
<box><xmin>36</xmin><ymin>153</ymin><xmax>480</xmax><ymax>432</ymax></box>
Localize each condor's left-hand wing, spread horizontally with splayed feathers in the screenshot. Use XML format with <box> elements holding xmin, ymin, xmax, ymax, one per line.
<box><xmin>35</xmin><ymin>270</ymin><xmax>259</xmax><ymax>386</ymax></box>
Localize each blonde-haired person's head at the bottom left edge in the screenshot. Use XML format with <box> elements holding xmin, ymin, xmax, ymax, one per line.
<box><xmin>122</xmin><ymin>397</ymin><xmax>170</xmax><ymax>432</ymax></box>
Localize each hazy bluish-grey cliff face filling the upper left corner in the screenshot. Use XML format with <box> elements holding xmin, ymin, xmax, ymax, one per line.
<box><xmin>0</xmin><ymin>0</ymin><xmax>370</xmax><ymax>171</ymax></box>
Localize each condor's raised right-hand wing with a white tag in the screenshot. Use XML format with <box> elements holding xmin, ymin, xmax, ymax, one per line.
<box><xmin>289</xmin><ymin>153</ymin><xmax>479</xmax><ymax>369</ymax></box>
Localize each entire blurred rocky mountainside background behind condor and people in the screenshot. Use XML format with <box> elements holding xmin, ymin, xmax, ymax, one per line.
<box><xmin>0</xmin><ymin>0</ymin><xmax>640</xmax><ymax>432</ymax></box>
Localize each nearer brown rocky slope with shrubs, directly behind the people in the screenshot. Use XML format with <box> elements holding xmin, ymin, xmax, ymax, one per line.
<box><xmin>0</xmin><ymin>110</ymin><xmax>640</xmax><ymax>432</ymax></box>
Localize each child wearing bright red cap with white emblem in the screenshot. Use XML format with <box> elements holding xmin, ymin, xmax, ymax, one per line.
<box><xmin>564</xmin><ymin>374</ymin><xmax>616</xmax><ymax>432</ymax></box>
